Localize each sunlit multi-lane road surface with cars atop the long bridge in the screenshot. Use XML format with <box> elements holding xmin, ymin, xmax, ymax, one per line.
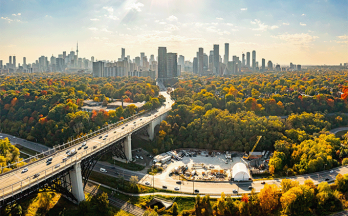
<box><xmin>0</xmin><ymin>92</ymin><xmax>174</xmax><ymax>200</ymax></box>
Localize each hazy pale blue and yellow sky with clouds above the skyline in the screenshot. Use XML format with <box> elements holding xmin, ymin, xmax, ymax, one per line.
<box><xmin>0</xmin><ymin>0</ymin><xmax>348</xmax><ymax>64</ymax></box>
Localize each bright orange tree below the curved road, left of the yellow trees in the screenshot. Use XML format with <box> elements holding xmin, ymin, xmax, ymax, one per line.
<box><xmin>258</xmin><ymin>184</ymin><xmax>279</xmax><ymax>214</ymax></box>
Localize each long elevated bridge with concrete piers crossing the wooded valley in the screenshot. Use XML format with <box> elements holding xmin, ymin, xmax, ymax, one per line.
<box><xmin>0</xmin><ymin>92</ymin><xmax>174</xmax><ymax>209</ymax></box>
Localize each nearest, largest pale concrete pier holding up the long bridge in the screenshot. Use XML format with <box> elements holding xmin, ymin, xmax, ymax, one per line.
<box><xmin>70</xmin><ymin>162</ymin><xmax>85</xmax><ymax>203</ymax></box>
